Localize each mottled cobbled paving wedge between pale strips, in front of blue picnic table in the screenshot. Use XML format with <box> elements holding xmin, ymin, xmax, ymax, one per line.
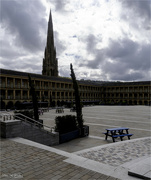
<box><xmin>76</xmin><ymin>138</ymin><xmax>151</xmax><ymax>167</ymax></box>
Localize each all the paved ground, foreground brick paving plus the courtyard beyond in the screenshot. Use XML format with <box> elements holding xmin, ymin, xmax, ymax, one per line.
<box><xmin>0</xmin><ymin>106</ymin><xmax>151</xmax><ymax>180</ymax></box>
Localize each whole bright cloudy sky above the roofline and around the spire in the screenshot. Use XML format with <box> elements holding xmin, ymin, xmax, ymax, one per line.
<box><xmin>0</xmin><ymin>0</ymin><xmax>151</xmax><ymax>81</ymax></box>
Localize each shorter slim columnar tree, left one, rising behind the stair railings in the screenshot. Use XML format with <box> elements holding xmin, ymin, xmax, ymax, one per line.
<box><xmin>28</xmin><ymin>74</ymin><xmax>39</xmax><ymax>121</ymax></box>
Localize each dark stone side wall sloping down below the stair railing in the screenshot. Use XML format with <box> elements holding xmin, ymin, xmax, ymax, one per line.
<box><xmin>0</xmin><ymin>120</ymin><xmax>59</xmax><ymax>146</ymax></box>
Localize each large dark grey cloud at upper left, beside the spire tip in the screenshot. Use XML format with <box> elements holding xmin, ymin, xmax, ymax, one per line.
<box><xmin>1</xmin><ymin>0</ymin><xmax>46</xmax><ymax>52</ymax></box>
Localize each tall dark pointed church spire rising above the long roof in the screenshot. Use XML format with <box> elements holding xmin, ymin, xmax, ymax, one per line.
<box><xmin>42</xmin><ymin>10</ymin><xmax>58</xmax><ymax>76</ymax></box>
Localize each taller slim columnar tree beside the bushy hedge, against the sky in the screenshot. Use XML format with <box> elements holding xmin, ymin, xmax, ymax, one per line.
<box><xmin>70</xmin><ymin>64</ymin><xmax>83</xmax><ymax>128</ymax></box>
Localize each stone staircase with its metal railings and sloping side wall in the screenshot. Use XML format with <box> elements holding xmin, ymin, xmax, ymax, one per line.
<box><xmin>0</xmin><ymin>111</ymin><xmax>59</xmax><ymax>146</ymax></box>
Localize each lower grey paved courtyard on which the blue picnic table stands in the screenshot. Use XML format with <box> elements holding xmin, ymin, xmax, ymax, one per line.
<box><xmin>40</xmin><ymin>106</ymin><xmax>151</xmax><ymax>152</ymax></box>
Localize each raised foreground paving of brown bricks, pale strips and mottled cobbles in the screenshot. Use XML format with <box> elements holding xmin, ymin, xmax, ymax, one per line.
<box><xmin>0</xmin><ymin>138</ymin><xmax>151</xmax><ymax>180</ymax></box>
